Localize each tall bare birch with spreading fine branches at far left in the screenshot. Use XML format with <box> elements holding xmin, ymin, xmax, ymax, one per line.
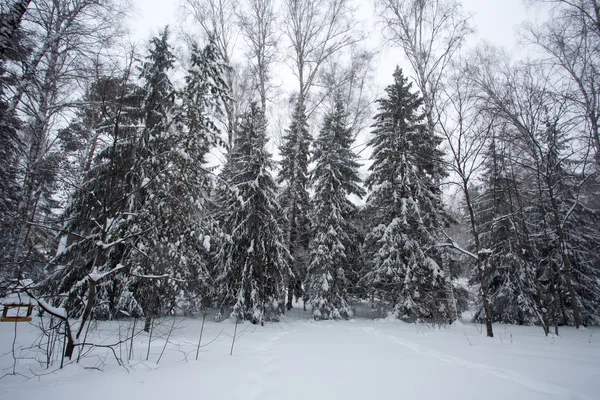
<box><xmin>0</xmin><ymin>0</ymin><xmax>126</xmax><ymax>282</ymax></box>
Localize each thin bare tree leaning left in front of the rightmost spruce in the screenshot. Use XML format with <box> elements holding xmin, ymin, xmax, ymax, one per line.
<box><xmin>473</xmin><ymin>45</ymin><xmax>587</xmax><ymax>327</ymax></box>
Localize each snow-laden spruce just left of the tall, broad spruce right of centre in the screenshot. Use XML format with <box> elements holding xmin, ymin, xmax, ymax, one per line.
<box><xmin>306</xmin><ymin>98</ymin><xmax>365</xmax><ymax>320</ymax></box>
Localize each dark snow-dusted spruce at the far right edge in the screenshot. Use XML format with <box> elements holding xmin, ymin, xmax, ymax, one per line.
<box><xmin>529</xmin><ymin>117</ymin><xmax>600</xmax><ymax>330</ymax></box>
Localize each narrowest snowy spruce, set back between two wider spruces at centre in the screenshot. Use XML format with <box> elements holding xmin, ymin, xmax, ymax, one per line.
<box><xmin>277</xmin><ymin>98</ymin><xmax>312</xmax><ymax>310</ymax></box>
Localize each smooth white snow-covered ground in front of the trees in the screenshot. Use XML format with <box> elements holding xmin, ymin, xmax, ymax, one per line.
<box><xmin>0</xmin><ymin>309</ymin><xmax>600</xmax><ymax>400</ymax></box>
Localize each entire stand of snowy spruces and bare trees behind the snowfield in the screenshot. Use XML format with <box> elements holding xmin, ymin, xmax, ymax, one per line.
<box><xmin>0</xmin><ymin>0</ymin><xmax>600</xmax><ymax>336</ymax></box>
